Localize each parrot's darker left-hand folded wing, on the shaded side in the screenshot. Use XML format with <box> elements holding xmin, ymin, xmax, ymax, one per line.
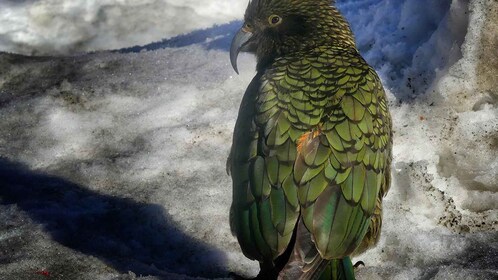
<box><xmin>229</xmin><ymin>68</ymin><xmax>299</xmax><ymax>263</ymax></box>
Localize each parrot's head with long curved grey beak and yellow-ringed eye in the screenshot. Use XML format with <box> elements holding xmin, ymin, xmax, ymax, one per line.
<box><xmin>230</xmin><ymin>0</ymin><xmax>355</xmax><ymax>73</ymax></box>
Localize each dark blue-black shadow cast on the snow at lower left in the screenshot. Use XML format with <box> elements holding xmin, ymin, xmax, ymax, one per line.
<box><xmin>0</xmin><ymin>157</ymin><xmax>226</xmax><ymax>280</ymax></box>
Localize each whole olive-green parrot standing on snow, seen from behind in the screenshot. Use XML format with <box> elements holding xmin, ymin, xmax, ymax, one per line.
<box><xmin>227</xmin><ymin>0</ymin><xmax>392</xmax><ymax>280</ymax></box>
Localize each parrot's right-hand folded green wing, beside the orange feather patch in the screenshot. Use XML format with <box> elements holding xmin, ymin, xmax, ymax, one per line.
<box><xmin>294</xmin><ymin>46</ymin><xmax>391</xmax><ymax>259</ymax></box>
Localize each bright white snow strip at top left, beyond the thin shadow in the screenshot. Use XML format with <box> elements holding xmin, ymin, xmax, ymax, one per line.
<box><xmin>0</xmin><ymin>0</ymin><xmax>247</xmax><ymax>55</ymax></box>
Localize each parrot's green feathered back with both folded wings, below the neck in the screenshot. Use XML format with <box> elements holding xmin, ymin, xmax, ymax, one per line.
<box><xmin>229</xmin><ymin>44</ymin><xmax>391</xmax><ymax>278</ymax></box>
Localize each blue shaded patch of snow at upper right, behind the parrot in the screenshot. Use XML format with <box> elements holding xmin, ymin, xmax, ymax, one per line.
<box><xmin>339</xmin><ymin>0</ymin><xmax>467</xmax><ymax>96</ymax></box>
